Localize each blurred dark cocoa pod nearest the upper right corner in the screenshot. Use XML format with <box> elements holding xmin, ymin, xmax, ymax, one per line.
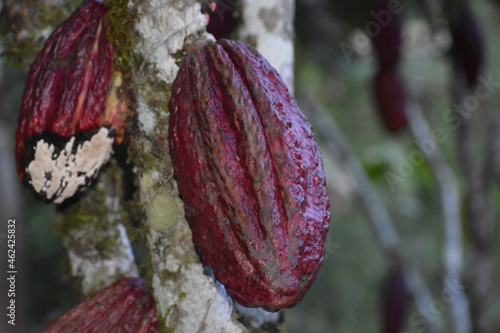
<box><xmin>450</xmin><ymin>5</ymin><xmax>484</xmax><ymax>87</ymax></box>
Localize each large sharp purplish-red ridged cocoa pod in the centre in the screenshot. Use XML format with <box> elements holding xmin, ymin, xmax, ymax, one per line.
<box><xmin>169</xmin><ymin>39</ymin><xmax>330</xmax><ymax>311</ymax></box>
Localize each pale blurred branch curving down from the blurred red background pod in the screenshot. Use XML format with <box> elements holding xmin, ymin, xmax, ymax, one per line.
<box><xmin>406</xmin><ymin>102</ymin><xmax>471</xmax><ymax>333</ymax></box>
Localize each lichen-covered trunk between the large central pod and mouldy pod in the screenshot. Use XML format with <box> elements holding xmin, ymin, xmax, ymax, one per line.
<box><xmin>130</xmin><ymin>0</ymin><xmax>244</xmax><ymax>333</ymax></box>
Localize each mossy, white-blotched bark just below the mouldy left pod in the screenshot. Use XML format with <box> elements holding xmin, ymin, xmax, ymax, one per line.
<box><xmin>53</xmin><ymin>163</ymin><xmax>138</xmax><ymax>295</ymax></box>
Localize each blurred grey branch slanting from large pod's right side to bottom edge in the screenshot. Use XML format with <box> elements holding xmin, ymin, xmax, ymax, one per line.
<box><xmin>301</xmin><ymin>89</ymin><xmax>442</xmax><ymax>332</ymax></box>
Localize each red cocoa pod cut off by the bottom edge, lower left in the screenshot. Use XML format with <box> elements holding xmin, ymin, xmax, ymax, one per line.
<box><xmin>44</xmin><ymin>278</ymin><xmax>158</xmax><ymax>333</ymax></box>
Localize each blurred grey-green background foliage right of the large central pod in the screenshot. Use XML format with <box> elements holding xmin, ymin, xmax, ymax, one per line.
<box><xmin>286</xmin><ymin>0</ymin><xmax>500</xmax><ymax>333</ymax></box>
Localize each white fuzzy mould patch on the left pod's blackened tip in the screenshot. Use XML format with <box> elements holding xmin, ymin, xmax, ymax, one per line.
<box><xmin>26</xmin><ymin>127</ymin><xmax>113</xmax><ymax>203</ymax></box>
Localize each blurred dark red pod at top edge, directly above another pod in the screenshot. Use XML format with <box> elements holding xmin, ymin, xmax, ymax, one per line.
<box><xmin>372</xmin><ymin>0</ymin><xmax>402</xmax><ymax>71</ymax></box>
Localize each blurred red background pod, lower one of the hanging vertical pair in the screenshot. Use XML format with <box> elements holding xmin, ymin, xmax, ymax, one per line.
<box><xmin>374</xmin><ymin>70</ymin><xmax>407</xmax><ymax>132</ymax></box>
